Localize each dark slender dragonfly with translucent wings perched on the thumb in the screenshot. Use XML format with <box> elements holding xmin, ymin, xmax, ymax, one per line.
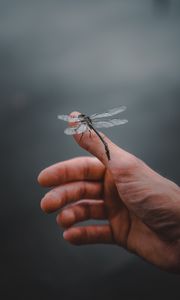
<box><xmin>58</xmin><ymin>106</ymin><xmax>128</xmax><ymax>160</ymax></box>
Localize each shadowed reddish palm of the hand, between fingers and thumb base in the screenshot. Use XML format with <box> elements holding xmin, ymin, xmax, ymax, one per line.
<box><xmin>103</xmin><ymin>171</ymin><xmax>179</xmax><ymax>268</ymax></box>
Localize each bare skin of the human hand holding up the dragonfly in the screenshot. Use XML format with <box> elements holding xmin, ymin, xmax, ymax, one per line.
<box><xmin>38</xmin><ymin>113</ymin><xmax>180</xmax><ymax>273</ymax></box>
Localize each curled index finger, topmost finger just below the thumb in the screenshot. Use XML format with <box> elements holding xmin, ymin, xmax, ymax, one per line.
<box><xmin>38</xmin><ymin>157</ymin><xmax>105</xmax><ymax>187</ymax></box>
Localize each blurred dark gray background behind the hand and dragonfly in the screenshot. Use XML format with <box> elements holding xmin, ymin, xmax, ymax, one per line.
<box><xmin>0</xmin><ymin>0</ymin><xmax>180</xmax><ymax>300</ymax></box>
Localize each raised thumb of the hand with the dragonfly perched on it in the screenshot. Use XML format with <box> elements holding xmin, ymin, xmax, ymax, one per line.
<box><xmin>70</xmin><ymin>112</ymin><xmax>132</xmax><ymax>169</ymax></box>
